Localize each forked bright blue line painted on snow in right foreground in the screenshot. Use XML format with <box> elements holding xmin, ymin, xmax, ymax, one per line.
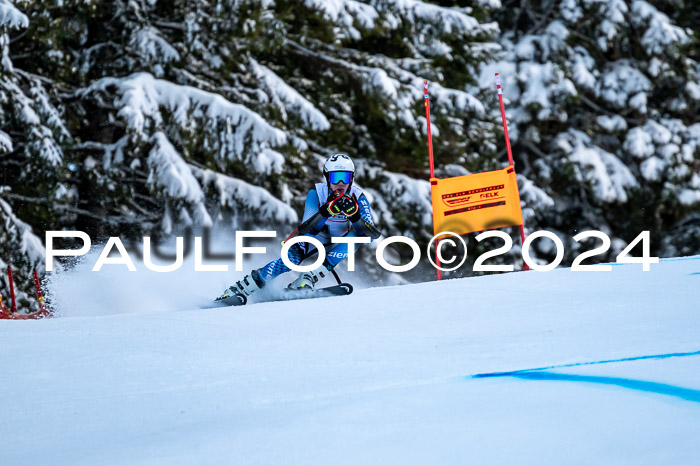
<box><xmin>467</xmin><ymin>351</ymin><xmax>700</xmax><ymax>403</ymax></box>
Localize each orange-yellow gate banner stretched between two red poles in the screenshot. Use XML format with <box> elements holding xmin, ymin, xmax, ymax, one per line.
<box><xmin>430</xmin><ymin>165</ymin><xmax>523</xmax><ymax>235</ymax></box>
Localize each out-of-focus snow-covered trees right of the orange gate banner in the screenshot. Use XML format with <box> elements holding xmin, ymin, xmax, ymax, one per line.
<box><xmin>490</xmin><ymin>0</ymin><xmax>700</xmax><ymax>261</ymax></box>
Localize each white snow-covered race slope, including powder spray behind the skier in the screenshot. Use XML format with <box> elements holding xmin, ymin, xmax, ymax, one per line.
<box><xmin>0</xmin><ymin>256</ymin><xmax>700</xmax><ymax>465</ymax></box>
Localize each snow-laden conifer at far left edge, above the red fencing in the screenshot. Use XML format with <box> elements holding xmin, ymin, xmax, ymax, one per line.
<box><xmin>0</xmin><ymin>0</ymin><xmax>64</xmax><ymax>310</ymax></box>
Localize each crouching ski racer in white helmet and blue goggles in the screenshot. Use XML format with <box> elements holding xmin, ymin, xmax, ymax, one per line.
<box><xmin>216</xmin><ymin>153</ymin><xmax>381</xmax><ymax>301</ymax></box>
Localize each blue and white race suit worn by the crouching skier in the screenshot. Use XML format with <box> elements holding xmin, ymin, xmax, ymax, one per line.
<box><xmin>258</xmin><ymin>183</ymin><xmax>374</xmax><ymax>282</ymax></box>
